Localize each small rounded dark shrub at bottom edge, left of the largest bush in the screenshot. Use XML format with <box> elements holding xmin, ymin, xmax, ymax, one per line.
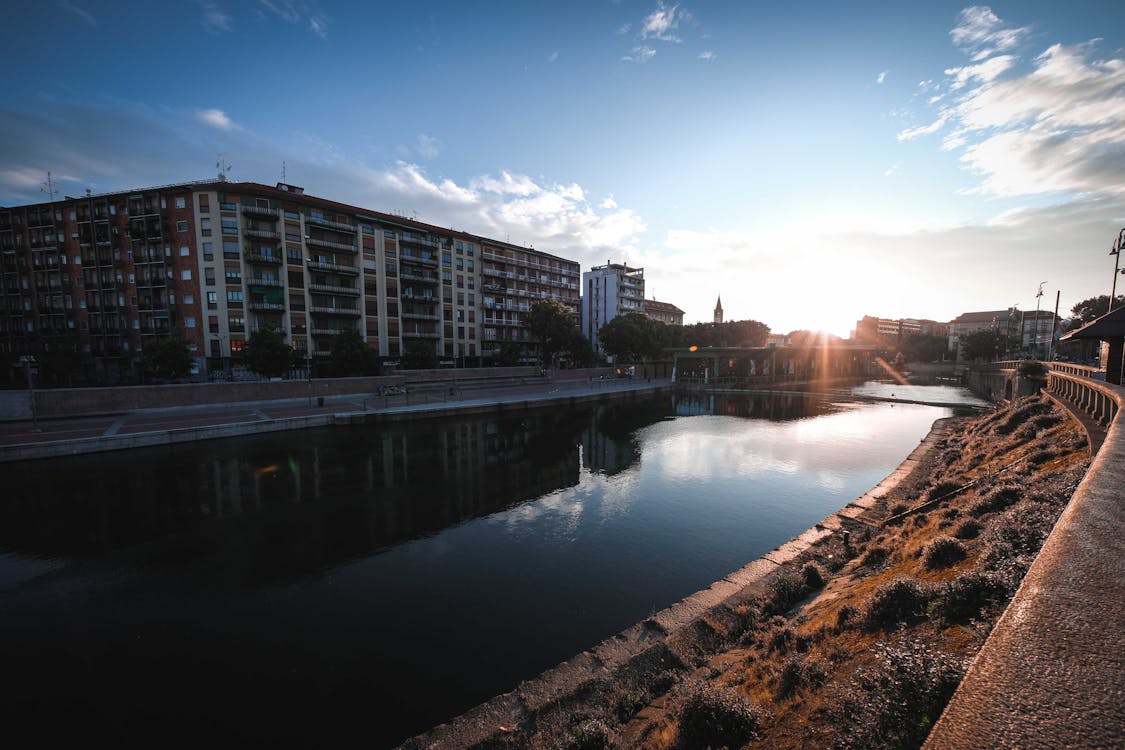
<box><xmin>680</xmin><ymin>683</ymin><xmax>765</xmax><ymax>748</ymax></box>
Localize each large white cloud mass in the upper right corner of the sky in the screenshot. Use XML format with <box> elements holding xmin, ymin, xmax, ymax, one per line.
<box><xmin>899</xmin><ymin>8</ymin><xmax>1125</xmax><ymax>196</ymax></box>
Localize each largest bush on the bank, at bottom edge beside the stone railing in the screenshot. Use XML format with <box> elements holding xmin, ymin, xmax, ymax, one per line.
<box><xmin>828</xmin><ymin>643</ymin><xmax>966</xmax><ymax>750</ymax></box>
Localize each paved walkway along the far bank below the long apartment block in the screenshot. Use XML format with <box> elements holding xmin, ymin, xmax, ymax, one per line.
<box><xmin>0</xmin><ymin>379</ymin><xmax>671</xmax><ymax>462</ymax></box>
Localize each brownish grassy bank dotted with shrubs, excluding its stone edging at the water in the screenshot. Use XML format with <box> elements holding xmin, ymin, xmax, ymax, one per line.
<box><xmin>465</xmin><ymin>397</ymin><xmax>1089</xmax><ymax>750</ymax></box>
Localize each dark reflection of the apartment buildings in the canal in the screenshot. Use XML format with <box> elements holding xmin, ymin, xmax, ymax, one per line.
<box><xmin>0</xmin><ymin>403</ymin><xmax>668</xmax><ymax>586</ymax></box>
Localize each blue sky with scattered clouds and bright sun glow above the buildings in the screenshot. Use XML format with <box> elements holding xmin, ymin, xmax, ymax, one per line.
<box><xmin>0</xmin><ymin>0</ymin><xmax>1125</xmax><ymax>336</ymax></box>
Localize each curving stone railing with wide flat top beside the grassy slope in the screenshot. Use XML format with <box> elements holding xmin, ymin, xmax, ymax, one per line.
<box><xmin>924</xmin><ymin>365</ymin><xmax>1125</xmax><ymax>750</ymax></box>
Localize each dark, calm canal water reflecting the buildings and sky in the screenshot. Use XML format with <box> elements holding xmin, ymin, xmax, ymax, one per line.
<box><xmin>0</xmin><ymin>386</ymin><xmax>985</xmax><ymax>748</ymax></box>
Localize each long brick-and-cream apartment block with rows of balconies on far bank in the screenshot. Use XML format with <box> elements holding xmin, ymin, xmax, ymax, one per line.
<box><xmin>0</xmin><ymin>179</ymin><xmax>579</xmax><ymax>381</ymax></box>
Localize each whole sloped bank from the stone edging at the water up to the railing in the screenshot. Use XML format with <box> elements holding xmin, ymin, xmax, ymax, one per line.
<box><xmin>401</xmin><ymin>400</ymin><xmax>1086</xmax><ymax>749</ymax></box>
